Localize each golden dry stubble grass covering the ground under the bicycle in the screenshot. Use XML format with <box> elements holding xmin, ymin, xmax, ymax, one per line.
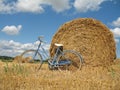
<box><xmin>0</xmin><ymin>59</ymin><xmax>120</xmax><ymax>90</ymax></box>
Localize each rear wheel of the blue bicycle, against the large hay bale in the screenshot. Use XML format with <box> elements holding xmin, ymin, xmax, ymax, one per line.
<box><xmin>57</xmin><ymin>50</ymin><xmax>83</xmax><ymax>71</ymax></box>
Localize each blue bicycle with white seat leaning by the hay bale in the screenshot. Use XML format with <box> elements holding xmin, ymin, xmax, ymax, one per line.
<box><xmin>21</xmin><ymin>36</ymin><xmax>84</xmax><ymax>71</ymax></box>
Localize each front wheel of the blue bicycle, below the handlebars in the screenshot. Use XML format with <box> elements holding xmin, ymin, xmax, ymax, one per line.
<box><xmin>20</xmin><ymin>50</ymin><xmax>43</xmax><ymax>69</ymax></box>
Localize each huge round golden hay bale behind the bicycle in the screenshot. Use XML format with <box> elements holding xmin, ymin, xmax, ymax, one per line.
<box><xmin>50</xmin><ymin>18</ymin><xmax>116</xmax><ymax>66</ymax></box>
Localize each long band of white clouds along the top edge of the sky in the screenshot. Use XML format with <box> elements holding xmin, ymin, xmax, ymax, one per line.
<box><xmin>0</xmin><ymin>0</ymin><xmax>111</xmax><ymax>14</ymax></box>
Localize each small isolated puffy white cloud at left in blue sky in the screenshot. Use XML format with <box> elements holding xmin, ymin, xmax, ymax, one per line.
<box><xmin>1</xmin><ymin>25</ymin><xmax>22</xmax><ymax>35</ymax></box>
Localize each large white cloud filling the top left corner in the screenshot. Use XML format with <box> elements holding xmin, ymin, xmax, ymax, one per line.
<box><xmin>0</xmin><ymin>0</ymin><xmax>44</xmax><ymax>14</ymax></box>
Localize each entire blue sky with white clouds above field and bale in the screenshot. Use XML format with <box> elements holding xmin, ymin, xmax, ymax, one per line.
<box><xmin>0</xmin><ymin>0</ymin><xmax>120</xmax><ymax>57</ymax></box>
